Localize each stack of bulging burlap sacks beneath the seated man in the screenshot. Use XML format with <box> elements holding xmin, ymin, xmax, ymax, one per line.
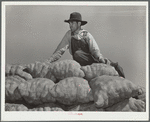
<box><xmin>5</xmin><ymin>60</ymin><xmax>146</xmax><ymax>112</ymax></box>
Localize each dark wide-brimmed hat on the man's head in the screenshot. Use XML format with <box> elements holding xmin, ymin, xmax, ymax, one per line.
<box><xmin>65</xmin><ymin>12</ymin><xmax>87</xmax><ymax>26</ymax></box>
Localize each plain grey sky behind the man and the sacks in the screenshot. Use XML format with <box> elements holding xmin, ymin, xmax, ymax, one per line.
<box><xmin>5</xmin><ymin>5</ymin><xmax>146</xmax><ymax>87</ymax></box>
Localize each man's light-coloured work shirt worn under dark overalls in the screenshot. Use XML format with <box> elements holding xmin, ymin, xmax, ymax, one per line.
<box><xmin>55</xmin><ymin>29</ymin><xmax>100</xmax><ymax>55</ymax></box>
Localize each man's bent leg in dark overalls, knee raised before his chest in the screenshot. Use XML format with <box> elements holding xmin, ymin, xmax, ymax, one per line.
<box><xmin>73</xmin><ymin>50</ymin><xmax>98</xmax><ymax>66</ymax></box>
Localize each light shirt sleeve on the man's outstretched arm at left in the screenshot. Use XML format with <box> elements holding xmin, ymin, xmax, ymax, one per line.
<box><xmin>53</xmin><ymin>30</ymin><xmax>71</xmax><ymax>54</ymax></box>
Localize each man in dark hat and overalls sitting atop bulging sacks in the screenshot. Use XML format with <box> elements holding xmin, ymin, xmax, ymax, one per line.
<box><xmin>54</xmin><ymin>12</ymin><xmax>105</xmax><ymax>66</ymax></box>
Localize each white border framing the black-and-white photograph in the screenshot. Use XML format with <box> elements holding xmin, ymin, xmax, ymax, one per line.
<box><xmin>1</xmin><ymin>1</ymin><xmax>149</xmax><ymax>121</ymax></box>
